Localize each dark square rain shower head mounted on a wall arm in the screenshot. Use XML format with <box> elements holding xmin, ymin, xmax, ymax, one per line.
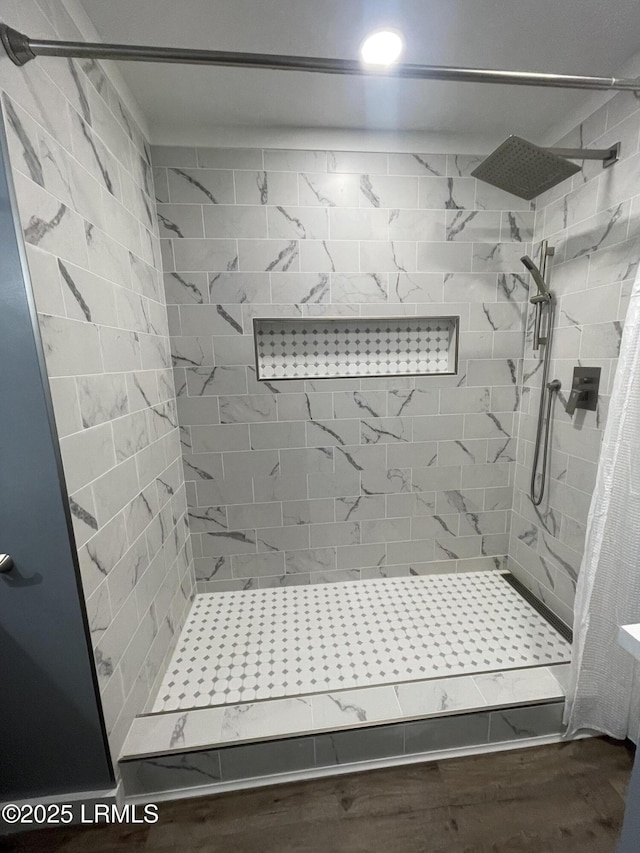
<box><xmin>471</xmin><ymin>136</ymin><xmax>580</xmax><ymax>201</ymax></box>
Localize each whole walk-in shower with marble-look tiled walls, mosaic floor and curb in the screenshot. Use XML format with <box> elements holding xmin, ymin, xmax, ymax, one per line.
<box><xmin>2</xmin><ymin>0</ymin><xmax>637</xmax><ymax>794</ymax></box>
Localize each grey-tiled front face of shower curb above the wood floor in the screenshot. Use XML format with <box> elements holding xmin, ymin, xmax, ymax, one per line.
<box><xmin>120</xmin><ymin>701</ymin><xmax>564</xmax><ymax>797</ymax></box>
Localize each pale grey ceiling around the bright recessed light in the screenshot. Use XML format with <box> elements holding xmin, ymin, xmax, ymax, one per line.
<box><xmin>77</xmin><ymin>0</ymin><xmax>640</xmax><ymax>144</ymax></box>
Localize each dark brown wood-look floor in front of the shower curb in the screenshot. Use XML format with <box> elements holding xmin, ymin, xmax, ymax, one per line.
<box><xmin>0</xmin><ymin>738</ymin><xmax>633</xmax><ymax>853</ymax></box>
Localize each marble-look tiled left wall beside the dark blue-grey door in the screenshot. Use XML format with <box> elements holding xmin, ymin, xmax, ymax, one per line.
<box><xmin>0</xmin><ymin>0</ymin><xmax>194</xmax><ymax>757</ymax></box>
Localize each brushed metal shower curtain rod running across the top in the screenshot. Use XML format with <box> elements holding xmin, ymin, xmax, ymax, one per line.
<box><xmin>0</xmin><ymin>24</ymin><xmax>640</xmax><ymax>92</ymax></box>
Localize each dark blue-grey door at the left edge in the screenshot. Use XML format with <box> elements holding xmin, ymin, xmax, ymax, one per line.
<box><xmin>0</xmin><ymin>111</ymin><xmax>113</xmax><ymax>800</ymax></box>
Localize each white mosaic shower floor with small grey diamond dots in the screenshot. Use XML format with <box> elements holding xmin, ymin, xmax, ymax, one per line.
<box><xmin>151</xmin><ymin>572</ymin><xmax>571</xmax><ymax>713</ymax></box>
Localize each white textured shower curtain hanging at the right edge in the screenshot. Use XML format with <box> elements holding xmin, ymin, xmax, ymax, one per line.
<box><xmin>565</xmin><ymin>269</ymin><xmax>640</xmax><ymax>742</ymax></box>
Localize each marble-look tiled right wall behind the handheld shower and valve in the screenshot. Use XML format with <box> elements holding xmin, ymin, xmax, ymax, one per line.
<box><xmin>509</xmin><ymin>93</ymin><xmax>640</xmax><ymax>624</ymax></box>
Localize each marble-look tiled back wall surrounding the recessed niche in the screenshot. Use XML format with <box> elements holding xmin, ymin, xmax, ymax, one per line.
<box><xmin>152</xmin><ymin>147</ymin><xmax>534</xmax><ymax>591</ymax></box>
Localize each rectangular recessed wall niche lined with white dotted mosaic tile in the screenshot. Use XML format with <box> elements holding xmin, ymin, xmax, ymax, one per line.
<box><xmin>253</xmin><ymin>316</ymin><xmax>460</xmax><ymax>381</ymax></box>
